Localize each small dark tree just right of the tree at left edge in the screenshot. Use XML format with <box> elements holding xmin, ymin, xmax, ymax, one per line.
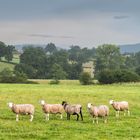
<box><xmin>4</xmin><ymin>45</ymin><xmax>15</xmax><ymax>62</ymax></box>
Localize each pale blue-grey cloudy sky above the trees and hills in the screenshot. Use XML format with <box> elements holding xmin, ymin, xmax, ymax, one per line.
<box><xmin>0</xmin><ymin>0</ymin><xmax>140</xmax><ymax>48</ymax></box>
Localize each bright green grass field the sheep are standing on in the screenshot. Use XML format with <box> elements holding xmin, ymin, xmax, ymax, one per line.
<box><xmin>0</xmin><ymin>80</ymin><xmax>140</xmax><ymax>140</ymax></box>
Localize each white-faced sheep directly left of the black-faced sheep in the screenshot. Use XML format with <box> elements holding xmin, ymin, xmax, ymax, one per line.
<box><xmin>40</xmin><ymin>100</ymin><xmax>64</xmax><ymax>121</ymax></box>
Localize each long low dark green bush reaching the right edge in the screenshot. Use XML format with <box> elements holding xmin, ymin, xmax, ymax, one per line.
<box><xmin>98</xmin><ymin>70</ymin><xmax>140</xmax><ymax>84</ymax></box>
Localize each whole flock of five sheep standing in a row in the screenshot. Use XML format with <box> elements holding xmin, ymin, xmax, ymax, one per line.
<box><xmin>8</xmin><ymin>100</ymin><xmax>130</xmax><ymax>124</ymax></box>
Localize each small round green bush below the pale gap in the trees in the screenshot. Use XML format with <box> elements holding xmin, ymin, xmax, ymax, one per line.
<box><xmin>79</xmin><ymin>72</ymin><xmax>92</xmax><ymax>85</ymax></box>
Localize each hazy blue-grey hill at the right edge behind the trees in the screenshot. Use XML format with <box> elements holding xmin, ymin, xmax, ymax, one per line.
<box><xmin>119</xmin><ymin>43</ymin><xmax>140</xmax><ymax>53</ymax></box>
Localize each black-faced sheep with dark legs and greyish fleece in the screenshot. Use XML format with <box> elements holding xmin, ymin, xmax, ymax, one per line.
<box><xmin>62</xmin><ymin>101</ymin><xmax>83</xmax><ymax>121</ymax></box>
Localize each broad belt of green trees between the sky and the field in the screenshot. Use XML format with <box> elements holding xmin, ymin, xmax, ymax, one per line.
<box><xmin>0</xmin><ymin>43</ymin><xmax>140</xmax><ymax>83</ymax></box>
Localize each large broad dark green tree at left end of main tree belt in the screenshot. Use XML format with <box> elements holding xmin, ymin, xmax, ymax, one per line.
<box><xmin>20</xmin><ymin>46</ymin><xmax>46</xmax><ymax>78</ymax></box>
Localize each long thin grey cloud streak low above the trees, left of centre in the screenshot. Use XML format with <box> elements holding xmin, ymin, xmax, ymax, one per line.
<box><xmin>29</xmin><ymin>34</ymin><xmax>75</xmax><ymax>39</ymax></box>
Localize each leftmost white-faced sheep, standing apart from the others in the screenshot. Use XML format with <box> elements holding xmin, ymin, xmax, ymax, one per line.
<box><xmin>8</xmin><ymin>102</ymin><xmax>35</xmax><ymax>122</ymax></box>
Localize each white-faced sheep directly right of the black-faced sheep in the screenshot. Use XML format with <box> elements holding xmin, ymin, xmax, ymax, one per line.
<box><xmin>87</xmin><ymin>103</ymin><xmax>109</xmax><ymax>124</ymax></box>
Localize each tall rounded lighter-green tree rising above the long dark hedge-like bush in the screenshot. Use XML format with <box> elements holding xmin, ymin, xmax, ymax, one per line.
<box><xmin>96</xmin><ymin>44</ymin><xmax>124</xmax><ymax>72</ymax></box>
